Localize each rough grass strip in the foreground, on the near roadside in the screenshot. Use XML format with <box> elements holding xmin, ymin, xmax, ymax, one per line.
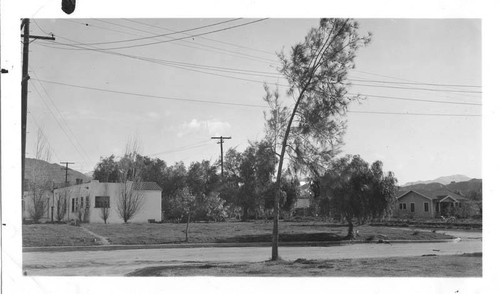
<box><xmin>128</xmin><ymin>253</ymin><xmax>482</xmax><ymax>277</ymax></box>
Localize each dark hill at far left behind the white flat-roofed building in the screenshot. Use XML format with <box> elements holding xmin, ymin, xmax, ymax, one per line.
<box><xmin>25</xmin><ymin>158</ymin><xmax>92</xmax><ymax>184</ymax></box>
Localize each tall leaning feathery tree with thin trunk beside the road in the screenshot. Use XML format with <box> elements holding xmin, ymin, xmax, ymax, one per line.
<box><xmin>264</xmin><ymin>19</ymin><xmax>371</xmax><ymax>260</ymax></box>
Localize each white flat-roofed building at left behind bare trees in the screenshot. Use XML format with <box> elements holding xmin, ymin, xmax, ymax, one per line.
<box><xmin>23</xmin><ymin>180</ymin><xmax>162</xmax><ymax>223</ymax></box>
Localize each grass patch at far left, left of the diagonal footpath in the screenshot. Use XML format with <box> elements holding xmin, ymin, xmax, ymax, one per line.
<box><xmin>23</xmin><ymin>224</ymin><xmax>96</xmax><ymax>247</ymax></box>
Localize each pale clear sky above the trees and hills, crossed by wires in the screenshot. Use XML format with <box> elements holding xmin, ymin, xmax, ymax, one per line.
<box><xmin>23</xmin><ymin>18</ymin><xmax>482</xmax><ymax>183</ymax></box>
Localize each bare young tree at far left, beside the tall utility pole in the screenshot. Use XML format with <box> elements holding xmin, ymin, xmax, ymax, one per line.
<box><xmin>28</xmin><ymin>129</ymin><xmax>52</xmax><ymax>222</ymax></box>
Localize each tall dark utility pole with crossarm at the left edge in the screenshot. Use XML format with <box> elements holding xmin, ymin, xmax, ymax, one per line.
<box><xmin>21</xmin><ymin>18</ymin><xmax>55</xmax><ymax>193</ymax></box>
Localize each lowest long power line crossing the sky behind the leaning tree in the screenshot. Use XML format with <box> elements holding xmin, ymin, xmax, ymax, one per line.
<box><xmin>36</xmin><ymin>79</ymin><xmax>481</xmax><ymax>116</ymax></box>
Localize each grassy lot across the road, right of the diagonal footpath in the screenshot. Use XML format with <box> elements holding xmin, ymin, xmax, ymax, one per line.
<box><xmin>37</xmin><ymin>221</ymin><xmax>451</xmax><ymax>246</ymax></box>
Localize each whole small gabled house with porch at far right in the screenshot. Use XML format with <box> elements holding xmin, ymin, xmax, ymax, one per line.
<box><xmin>393</xmin><ymin>189</ymin><xmax>470</xmax><ymax>218</ymax></box>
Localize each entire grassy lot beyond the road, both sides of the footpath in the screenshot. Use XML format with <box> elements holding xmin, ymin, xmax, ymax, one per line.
<box><xmin>23</xmin><ymin>221</ymin><xmax>451</xmax><ymax>247</ymax></box>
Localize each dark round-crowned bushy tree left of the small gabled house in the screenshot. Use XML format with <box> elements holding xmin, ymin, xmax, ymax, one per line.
<box><xmin>319</xmin><ymin>155</ymin><xmax>398</xmax><ymax>239</ymax></box>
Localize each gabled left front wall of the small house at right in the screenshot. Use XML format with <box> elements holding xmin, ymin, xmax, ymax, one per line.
<box><xmin>393</xmin><ymin>191</ymin><xmax>435</xmax><ymax>218</ymax></box>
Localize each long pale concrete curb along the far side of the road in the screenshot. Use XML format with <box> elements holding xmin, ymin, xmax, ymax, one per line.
<box><xmin>23</xmin><ymin>238</ymin><xmax>460</xmax><ymax>252</ymax></box>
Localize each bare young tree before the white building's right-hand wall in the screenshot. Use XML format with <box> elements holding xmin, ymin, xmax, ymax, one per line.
<box><xmin>116</xmin><ymin>139</ymin><xmax>144</xmax><ymax>223</ymax></box>
